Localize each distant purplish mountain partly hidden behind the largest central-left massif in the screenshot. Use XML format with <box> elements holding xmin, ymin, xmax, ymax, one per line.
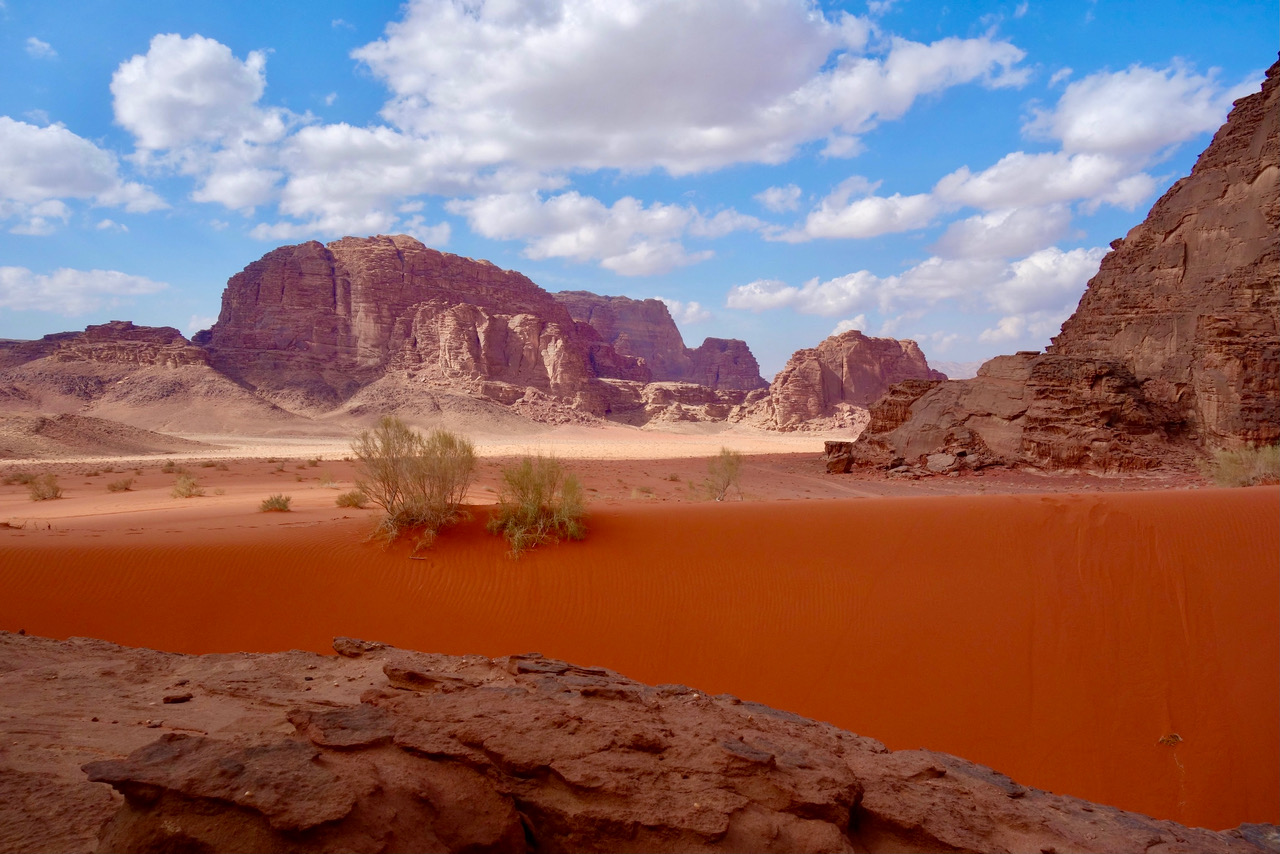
<box><xmin>552</xmin><ymin>291</ymin><xmax>768</xmax><ymax>391</ymax></box>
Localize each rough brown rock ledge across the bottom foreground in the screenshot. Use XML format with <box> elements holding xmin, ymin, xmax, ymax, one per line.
<box><xmin>0</xmin><ymin>632</ymin><xmax>1280</xmax><ymax>854</ymax></box>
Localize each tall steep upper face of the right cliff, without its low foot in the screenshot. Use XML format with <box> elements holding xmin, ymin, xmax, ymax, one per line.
<box><xmin>1048</xmin><ymin>63</ymin><xmax>1280</xmax><ymax>447</ymax></box>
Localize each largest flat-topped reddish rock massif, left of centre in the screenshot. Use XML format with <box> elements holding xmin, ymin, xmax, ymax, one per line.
<box><xmin>200</xmin><ymin>236</ymin><xmax>646</xmax><ymax>411</ymax></box>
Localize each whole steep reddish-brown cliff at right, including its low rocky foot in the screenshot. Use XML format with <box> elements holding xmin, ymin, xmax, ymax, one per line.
<box><xmin>854</xmin><ymin>63</ymin><xmax>1280</xmax><ymax>471</ymax></box>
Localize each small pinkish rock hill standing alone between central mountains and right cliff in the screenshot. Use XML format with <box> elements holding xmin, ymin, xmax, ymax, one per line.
<box><xmin>755</xmin><ymin>329</ymin><xmax>946</xmax><ymax>430</ymax></box>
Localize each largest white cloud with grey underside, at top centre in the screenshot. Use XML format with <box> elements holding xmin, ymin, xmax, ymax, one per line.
<box><xmin>353</xmin><ymin>0</ymin><xmax>1025</xmax><ymax>174</ymax></box>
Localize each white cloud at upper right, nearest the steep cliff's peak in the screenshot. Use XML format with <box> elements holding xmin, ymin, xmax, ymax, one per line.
<box><xmin>1023</xmin><ymin>65</ymin><xmax>1257</xmax><ymax>157</ymax></box>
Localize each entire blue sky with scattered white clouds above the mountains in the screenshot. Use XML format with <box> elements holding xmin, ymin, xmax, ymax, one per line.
<box><xmin>0</xmin><ymin>0</ymin><xmax>1277</xmax><ymax>376</ymax></box>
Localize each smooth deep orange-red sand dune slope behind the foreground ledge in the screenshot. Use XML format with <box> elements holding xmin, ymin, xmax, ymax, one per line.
<box><xmin>0</xmin><ymin>488</ymin><xmax>1280</xmax><ymax>828</ymax></box>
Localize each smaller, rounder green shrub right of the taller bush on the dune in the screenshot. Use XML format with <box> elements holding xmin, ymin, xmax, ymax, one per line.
<box><xmin>486</xmin><ymin>456</ymin><xmax>586</xmax><ymax>557</ymax></box>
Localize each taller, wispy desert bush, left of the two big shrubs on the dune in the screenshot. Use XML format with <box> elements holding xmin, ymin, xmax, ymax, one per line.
<box><xmin>351</xmin><ymin>416</ymin><xmax>476</xmax><ymax>545</ymax></box>
